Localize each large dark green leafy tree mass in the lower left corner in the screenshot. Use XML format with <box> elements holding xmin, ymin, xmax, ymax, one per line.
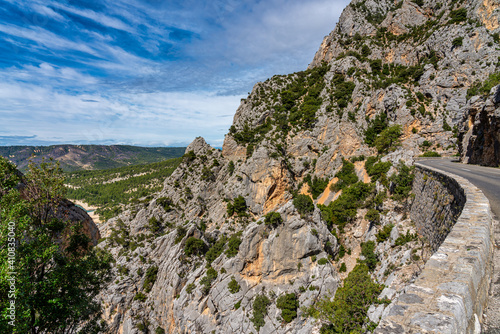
<box><xmin>0</xmin><ymin>158</ymin><xmax>112</xmax><ymax>334</ymax></box>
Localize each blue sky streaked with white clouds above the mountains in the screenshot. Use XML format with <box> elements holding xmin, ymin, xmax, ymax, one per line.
<box><xmin>0</xmin><ymin>0</ymin><xmax>348</xmax><ymax>147</ymax></box>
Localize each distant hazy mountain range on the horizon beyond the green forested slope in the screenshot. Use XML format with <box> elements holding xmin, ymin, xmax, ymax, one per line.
<box><xmin>0</xmin><ymin>145</ymin><xmax>186</xmax><ymax>171</ymax></box>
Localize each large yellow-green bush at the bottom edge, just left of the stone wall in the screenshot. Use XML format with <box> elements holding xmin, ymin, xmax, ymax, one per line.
<box><xmin>305</xmin><ymin>264</ymin><xmax>383</xmax><ymax>333</ymax></box>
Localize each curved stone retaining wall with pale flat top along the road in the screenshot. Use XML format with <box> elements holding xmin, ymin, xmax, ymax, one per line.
<box><xmin>374</xmin><ymin>163</ymin><xmax>493</xmax><ymax>334</ymax></box>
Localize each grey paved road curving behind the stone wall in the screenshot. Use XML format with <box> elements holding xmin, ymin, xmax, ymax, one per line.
<box><xmin>418</xmin><ymin>159</ymin><xmax>500</xmax><ymax>334</ymax></box>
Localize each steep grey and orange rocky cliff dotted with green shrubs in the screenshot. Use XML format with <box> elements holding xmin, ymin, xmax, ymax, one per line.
<box><xmin>96</xmin><ymin>0</ymin><xmax>500</xmax><ymax>333</ymax></box>
